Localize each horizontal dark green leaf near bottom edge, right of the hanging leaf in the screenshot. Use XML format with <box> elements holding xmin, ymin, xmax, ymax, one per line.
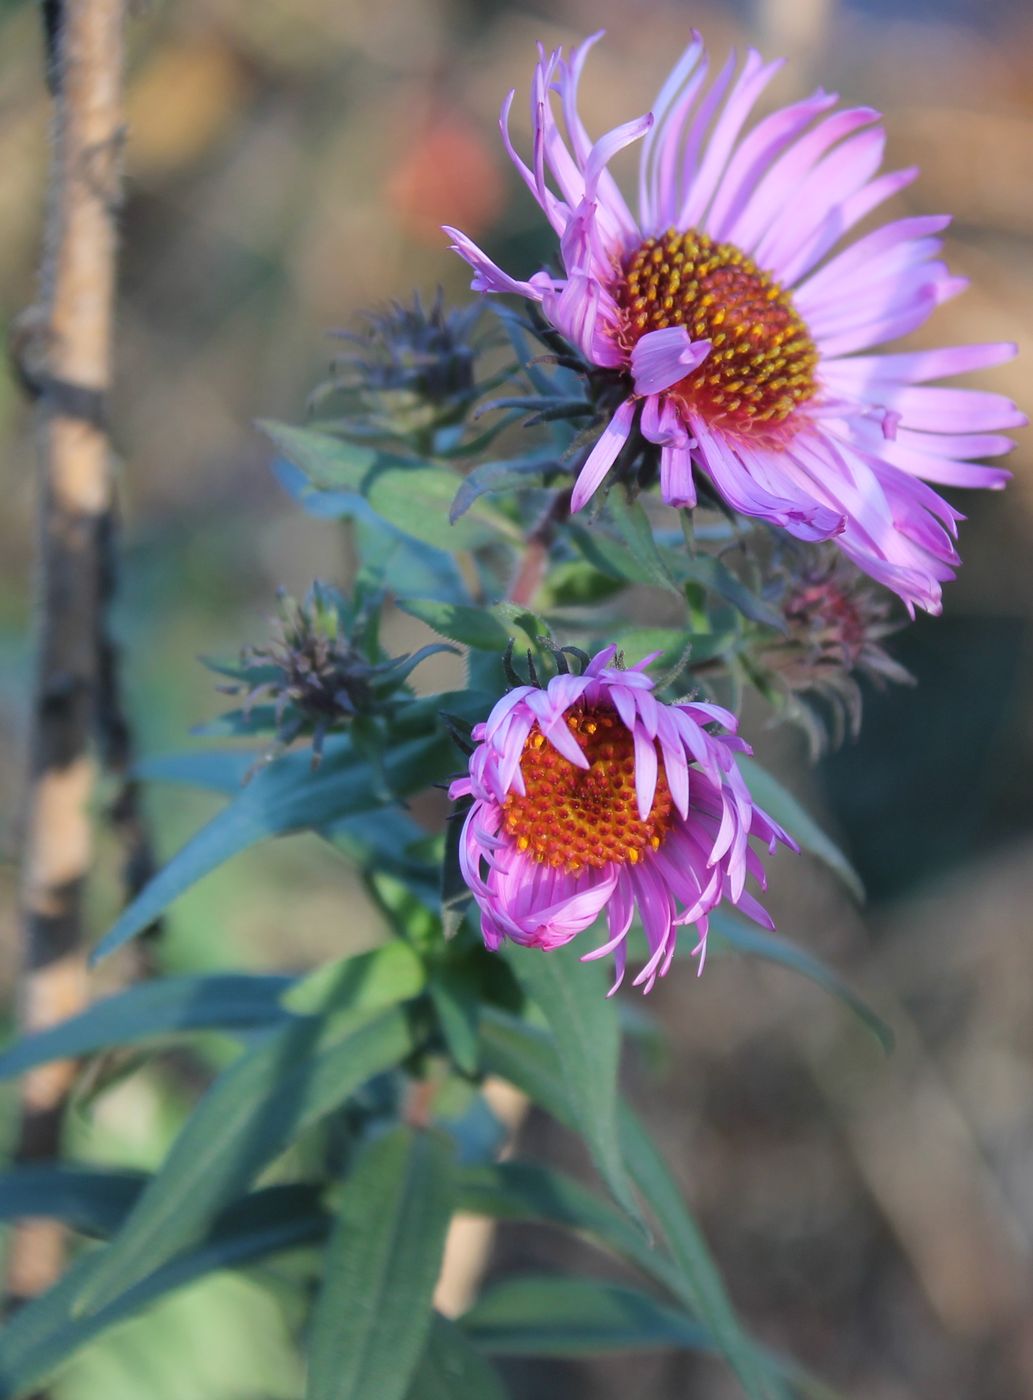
<box><xmin>461</xmin><ymin>1274</ymin><xmax>714</xmax><ymax>1357</ymax></box>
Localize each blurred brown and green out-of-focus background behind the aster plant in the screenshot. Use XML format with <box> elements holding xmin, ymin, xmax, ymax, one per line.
<box><xmin>0</xmin><ymin>0</ymin><xmax>1033</xmax><ymax>1400</ymax></box>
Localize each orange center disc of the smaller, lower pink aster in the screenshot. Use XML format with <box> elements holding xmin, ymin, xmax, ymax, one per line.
<box><xmin>503</xmin><ymin>704</ymin><xmax>673</xmax><ymax>872</ymax></box>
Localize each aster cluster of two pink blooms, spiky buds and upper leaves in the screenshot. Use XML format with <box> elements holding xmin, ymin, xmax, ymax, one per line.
<box><xmin>249</xmin><ymin>27</ymin><xmax>1022</xmax><ymax>991</ymax></box>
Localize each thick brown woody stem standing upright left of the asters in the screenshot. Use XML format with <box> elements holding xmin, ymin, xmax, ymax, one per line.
<box><xmin>7</xmin><ymin>0</ymin><xmax>123</xmax><ymax>1302</ymax></box>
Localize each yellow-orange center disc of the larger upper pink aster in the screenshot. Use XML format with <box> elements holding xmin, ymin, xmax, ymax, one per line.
<box><xmin>614</xmin><ymin>228</ymin><xmax>817</xmax><ymax>434</ymax></box>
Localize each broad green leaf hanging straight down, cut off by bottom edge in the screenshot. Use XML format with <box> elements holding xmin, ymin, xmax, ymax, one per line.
<box><xmin>305</xmin><ymin>1127</ymin><xmax>454</xmax><ymax>1400</ymax></box>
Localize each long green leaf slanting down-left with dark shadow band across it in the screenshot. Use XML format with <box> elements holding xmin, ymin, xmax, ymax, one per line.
<box><xmin>78</xmin><ymin>1008</ymin><xmax>413</xmax><ymax>1313</ymax></box>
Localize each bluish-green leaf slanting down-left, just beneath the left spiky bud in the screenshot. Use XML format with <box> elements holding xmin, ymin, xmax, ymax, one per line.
<box><xmin>92</xmin><ymin>734</ymin><xmax>455</xmax><ymax>960</ymax></box>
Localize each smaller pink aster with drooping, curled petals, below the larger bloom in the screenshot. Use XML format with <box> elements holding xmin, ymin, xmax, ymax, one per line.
<box><xmin>451</xmin><ymin>647</ymin><xmax>796</xmax><ymax>991</ymax></box>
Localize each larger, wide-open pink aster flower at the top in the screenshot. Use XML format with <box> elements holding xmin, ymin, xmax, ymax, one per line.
<box><xmin>445</xmin><ymin>35</ymin><xmax>1025</xmax><ymax>612</ymax></box>
